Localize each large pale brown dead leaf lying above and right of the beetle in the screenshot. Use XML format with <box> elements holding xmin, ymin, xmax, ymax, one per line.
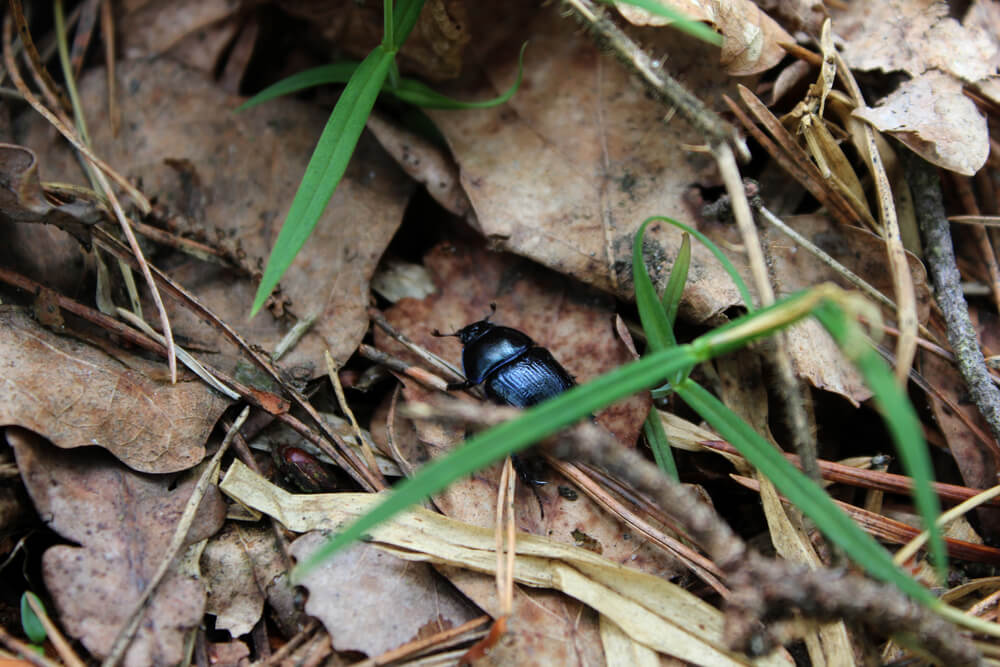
<box><xmin>430</xmin><ymin>8</ymin><xmax>739</xmax><ymax>321</ymax></box>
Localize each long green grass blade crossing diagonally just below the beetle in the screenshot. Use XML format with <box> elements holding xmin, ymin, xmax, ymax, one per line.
<box><xmin>293</xmin><ymin>346</ymin><xmax>692</xmax><ymax>577</ymax></box>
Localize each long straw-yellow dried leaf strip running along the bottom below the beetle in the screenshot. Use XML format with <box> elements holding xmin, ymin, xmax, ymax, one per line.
<box><xmin>220</xmin><ymin>461</ymin><xmax>792</xmax><ymax>665</ymax></box>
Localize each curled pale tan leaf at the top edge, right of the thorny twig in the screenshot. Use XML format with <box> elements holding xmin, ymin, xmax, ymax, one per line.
<box><xmin>615</xmin><ymin>0</ymin><xmax>795</xmax><ymax>76</ymax></box>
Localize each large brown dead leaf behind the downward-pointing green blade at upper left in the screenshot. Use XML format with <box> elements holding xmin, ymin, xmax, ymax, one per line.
<box><xmin>19</xmin><ymin>59</ymin><xmax>413</xmax><ymax>378</ymax></box>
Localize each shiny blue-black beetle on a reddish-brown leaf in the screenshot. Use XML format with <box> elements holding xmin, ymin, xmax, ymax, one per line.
<box><xmin>434</xmin><ymin>304</ymin><xmax>576</xmax><ymax>408</ymax></box>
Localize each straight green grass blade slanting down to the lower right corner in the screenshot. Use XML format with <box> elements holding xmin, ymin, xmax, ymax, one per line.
<box><xmin>676</xmin><ymin>381</ymin><xmax>937</xmax><ymax>604</ymax></box>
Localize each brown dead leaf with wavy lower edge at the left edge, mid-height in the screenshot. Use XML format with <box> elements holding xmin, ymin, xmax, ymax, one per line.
<box><xmin>0</xmin><ymin>307</ymin><xmax>229</xmax><ymax>473</ymax></box>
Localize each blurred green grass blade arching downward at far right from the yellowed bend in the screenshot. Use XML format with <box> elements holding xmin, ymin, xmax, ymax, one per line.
<box><xmin>815</xmin><ymin>303</ymin><xmax>948</xmax><ymax>581</ymax></box>
